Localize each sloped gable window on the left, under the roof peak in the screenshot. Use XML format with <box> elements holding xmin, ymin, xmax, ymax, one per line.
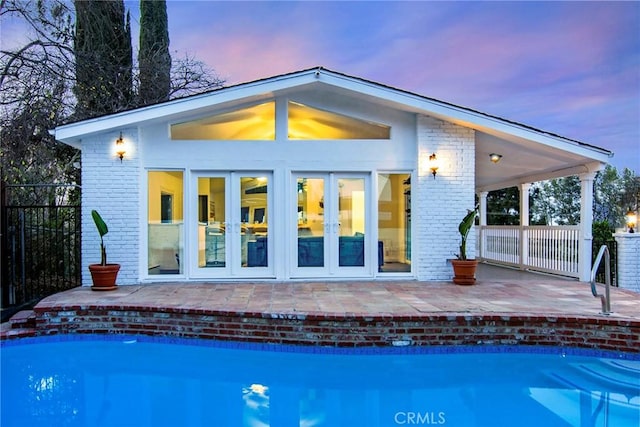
<box><xmin>171</xmin><ymin>101</ymin><xmax>276</xmax><ymax>141</ymax></box>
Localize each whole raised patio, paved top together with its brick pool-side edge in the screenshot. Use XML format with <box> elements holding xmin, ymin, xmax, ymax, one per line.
<box><xmin>5</xmin><ymin>266</ymin><xmax>640</xmax><ymax>353</ymax></box>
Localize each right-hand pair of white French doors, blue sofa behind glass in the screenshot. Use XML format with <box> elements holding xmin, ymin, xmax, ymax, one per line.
<box><xmin>290</xmin><ymin>173</ymin><xmax>372</xmax><ymax>277</ymax></box>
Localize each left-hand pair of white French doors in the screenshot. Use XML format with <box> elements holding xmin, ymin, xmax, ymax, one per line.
<box><xmin>191</xmin><ymin>172</ymin><xmax>274</xmax><ymax>277</ymax></box>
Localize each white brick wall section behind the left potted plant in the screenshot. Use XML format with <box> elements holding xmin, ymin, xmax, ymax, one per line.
<box><xmin>82</xmin><ymin>129</ymin><xmax>140</xmax><ymax>286</ymax></box>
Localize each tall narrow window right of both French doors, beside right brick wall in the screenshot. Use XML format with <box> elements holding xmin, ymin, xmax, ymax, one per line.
<box><xmin>378</xmin><ymin>174</ymin><xmax>411</xmax><ymax>273</ymax></box>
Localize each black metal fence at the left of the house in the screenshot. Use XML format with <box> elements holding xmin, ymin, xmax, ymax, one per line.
<box><xmin>0</xmin><ymin>186</ymin><xmax>81</xmax><ymax>321</ymax></box>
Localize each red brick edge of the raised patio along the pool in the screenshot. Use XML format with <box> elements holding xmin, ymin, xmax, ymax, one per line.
<box><xmin>11</xmin><ymin>305</ymin><xmax>640</xmax><ymax>353</ymax></box>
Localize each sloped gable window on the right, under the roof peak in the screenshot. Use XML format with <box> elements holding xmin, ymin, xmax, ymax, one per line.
<box><xmin>288</xmin><ymin>102</ymin><xmax>391</xmax><ymax>140</ymax></box>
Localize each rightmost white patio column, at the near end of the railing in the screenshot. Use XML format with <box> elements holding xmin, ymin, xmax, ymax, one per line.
<box><xmin>578</xmin><ymin>172</ymin><xmax>596</xmax><ymax>282</ymax></box>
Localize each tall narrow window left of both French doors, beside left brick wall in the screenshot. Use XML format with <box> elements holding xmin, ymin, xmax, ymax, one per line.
<box><xmin>147</xmin><ymin>171</ymin><xmax>184</xmax><ymax>274</ymax></box>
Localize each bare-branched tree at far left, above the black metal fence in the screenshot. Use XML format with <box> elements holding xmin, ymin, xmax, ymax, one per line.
<box><xmin>0</xmin><ymin>1</ymin><xmax>80</xmax><ymax>203</ymax></box>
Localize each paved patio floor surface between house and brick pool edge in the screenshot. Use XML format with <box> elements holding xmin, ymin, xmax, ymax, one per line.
<box><xmin>31</xmin><ymin>266</ymin><xmax>640</xmax><ymax>321</ymax></box>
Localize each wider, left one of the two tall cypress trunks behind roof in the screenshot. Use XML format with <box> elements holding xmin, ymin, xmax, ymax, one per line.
<box><xmin>74</xmin><ymin>0</ymin><xmax>133</xmax><ymax>119</ymax></box>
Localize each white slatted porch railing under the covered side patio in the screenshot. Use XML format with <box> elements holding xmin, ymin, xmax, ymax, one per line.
<box><xmin>476</xmin><ymin>225</ymin><xmax>580</xmax><ymax>277</ymax></box>
